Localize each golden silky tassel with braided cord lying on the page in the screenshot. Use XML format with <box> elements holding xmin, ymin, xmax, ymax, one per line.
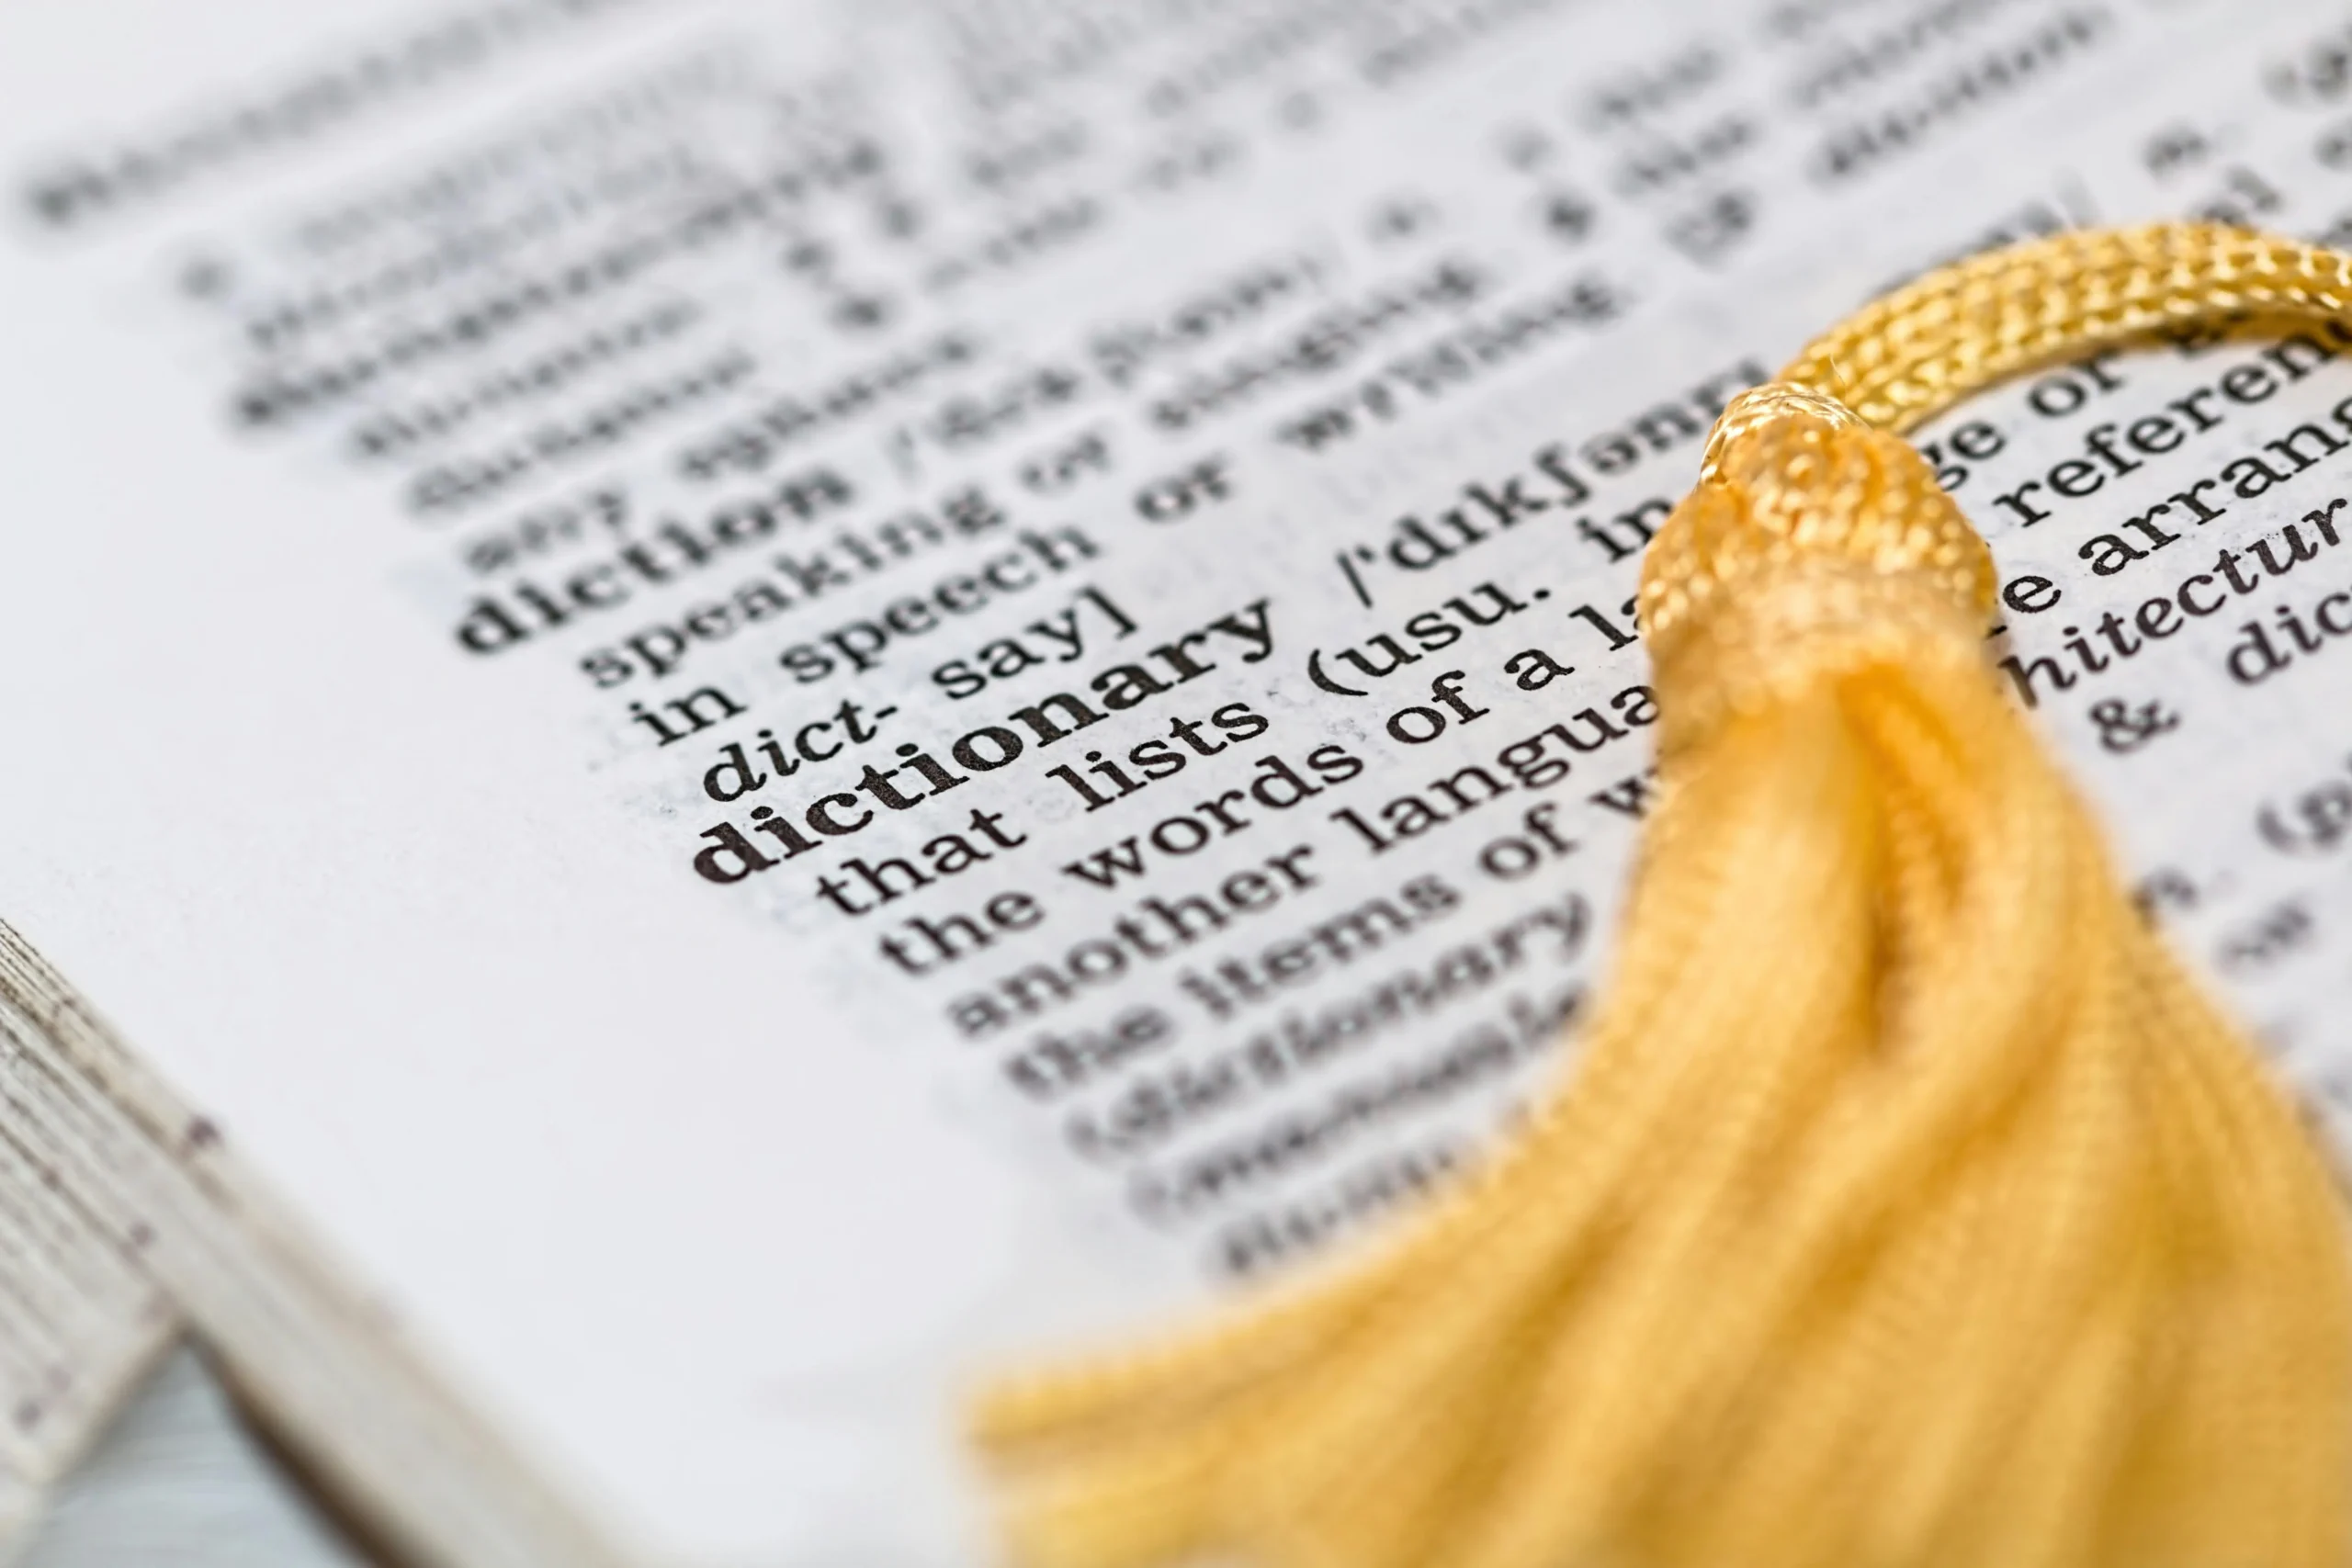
<box><xmin>978</xmin><ymin>226</ymin><xmax>2352</xmax><ymax>1568</ymax></box>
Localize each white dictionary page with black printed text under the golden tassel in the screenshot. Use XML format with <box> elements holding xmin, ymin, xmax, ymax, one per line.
<box><xmin>14</xmin><ymin>0</ymin><xmax>2352</xmax><ymax>1568</ymax></box>
